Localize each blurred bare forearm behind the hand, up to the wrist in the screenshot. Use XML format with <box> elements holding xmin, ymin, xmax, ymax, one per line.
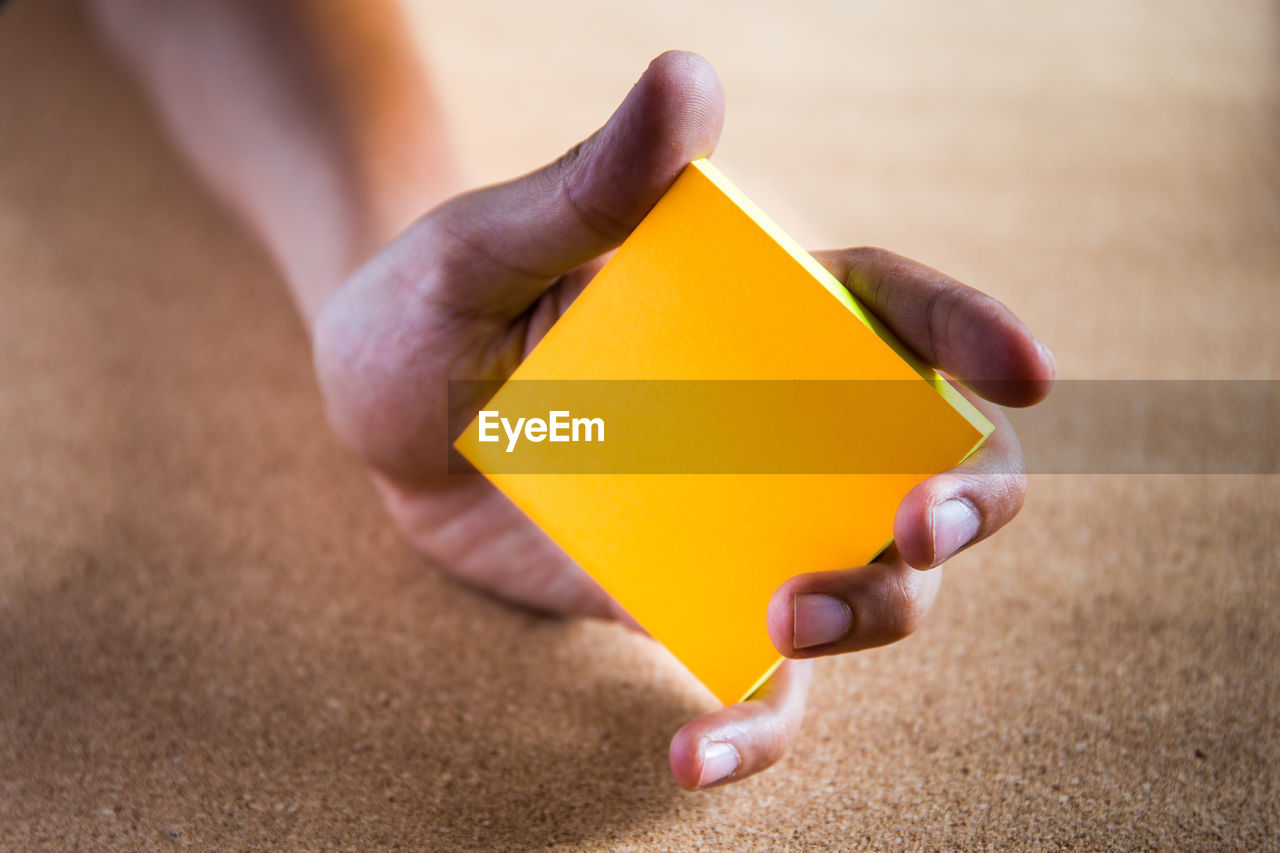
<box><xmin>86</xmin><ymin>0</ymin><xmax>454</xmax><ymax>327</ymax></box>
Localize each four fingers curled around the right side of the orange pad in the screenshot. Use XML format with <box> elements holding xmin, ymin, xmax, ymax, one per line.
<box><xmin>671</xmin><ymin>248</ymin><xmax>1056</xmax><ymax>789</ymax></box>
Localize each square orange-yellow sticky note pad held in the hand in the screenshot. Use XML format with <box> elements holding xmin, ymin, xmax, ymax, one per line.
<box><xmin>454</xmin><ymin>160</ymin><xmax>992</xmax><ymax>703</ymax></box>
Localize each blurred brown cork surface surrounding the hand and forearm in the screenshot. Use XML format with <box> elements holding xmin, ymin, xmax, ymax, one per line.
<box><xmin>0</xmin><ymin>0</ymin><xmax>1280</xmax><ymax>850</ymax></box>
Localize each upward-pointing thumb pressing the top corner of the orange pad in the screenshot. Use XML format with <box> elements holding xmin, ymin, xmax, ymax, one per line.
<box><xmin>411</xmin><ymin>51</ymin><xmax>724</xmax><ymax>318</ymax></box>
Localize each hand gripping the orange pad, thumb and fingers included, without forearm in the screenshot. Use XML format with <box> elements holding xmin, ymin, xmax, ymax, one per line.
<box><xmin>315</xmin><ymin>53</ymin><xmax>1052</xmax><ymax>788</ymax></box>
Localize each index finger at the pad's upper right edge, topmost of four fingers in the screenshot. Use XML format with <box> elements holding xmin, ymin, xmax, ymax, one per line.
<box><xmin>814</xmin><ymin>248</ymin><xmax>1056</xmax><ymax>406</ymax></box>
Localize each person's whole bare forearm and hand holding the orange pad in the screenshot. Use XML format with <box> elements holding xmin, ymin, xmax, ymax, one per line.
<box><xmin>90</xmin><ymin>0</ymin><xmax>1055</xmax><ymax>789</ymax></box>
